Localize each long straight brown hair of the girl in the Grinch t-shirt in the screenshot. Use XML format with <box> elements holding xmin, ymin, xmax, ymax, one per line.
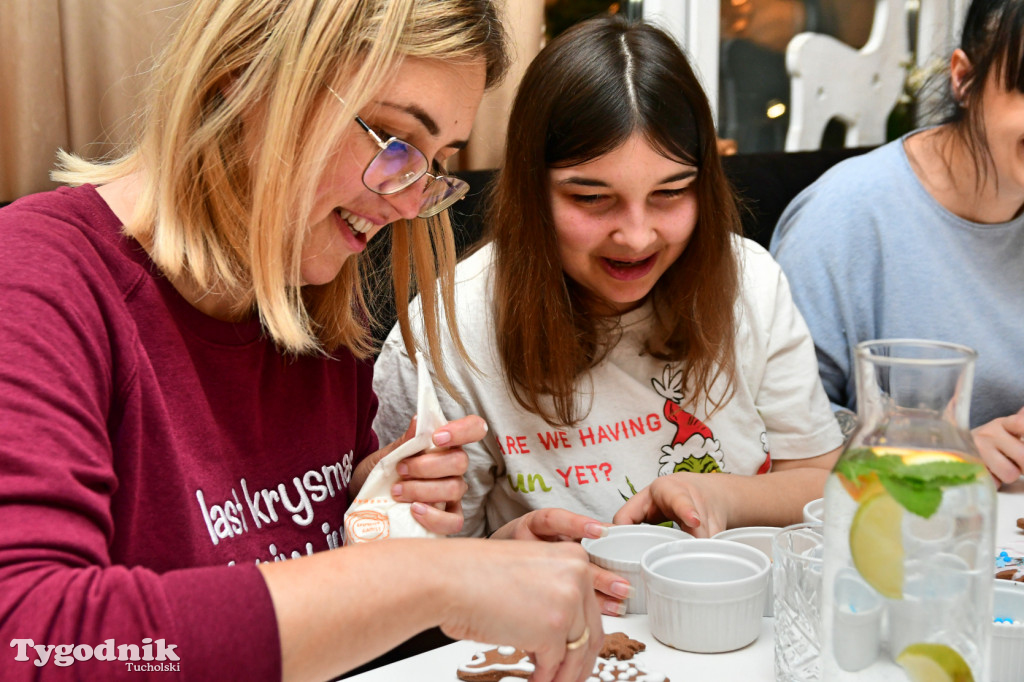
<box><xmin>488</xmin><ymin>15</ymin><xmax>740</xmax><ymax>425</ymax></box>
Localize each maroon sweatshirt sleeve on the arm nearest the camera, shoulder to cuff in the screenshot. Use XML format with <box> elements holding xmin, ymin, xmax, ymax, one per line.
<box><xmin>0</xmin><ymin>207</ymin><xmax>281</xmax><ymax>680</ymax></box>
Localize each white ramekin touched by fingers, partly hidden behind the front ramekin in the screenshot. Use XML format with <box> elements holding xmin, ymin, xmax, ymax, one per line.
<box><xmin>581</xmin><ymin>523</ymin><xmax>692</xmax><ymax>613</ymax></box>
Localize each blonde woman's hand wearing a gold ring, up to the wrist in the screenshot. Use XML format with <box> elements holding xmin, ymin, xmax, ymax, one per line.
<box><xmin>440</xmin><ymin>540</ymin><xmax>604</xmax><ymax>682</ymax></box>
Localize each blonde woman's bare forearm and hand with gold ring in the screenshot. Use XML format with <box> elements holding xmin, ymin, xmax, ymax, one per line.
<box><xmin>258</xmin><ymin>538</ymin><xmax>604</xmax><ymax>682</ymax></box>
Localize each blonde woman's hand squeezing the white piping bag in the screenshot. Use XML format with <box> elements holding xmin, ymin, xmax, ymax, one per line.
<box><xmin>349</xmin><ymin>415</ymin><xmax>487</xmax><ymax>536</ymax></box>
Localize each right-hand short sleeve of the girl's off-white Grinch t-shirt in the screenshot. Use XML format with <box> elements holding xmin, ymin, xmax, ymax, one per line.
<box><xmin>749</xmin><ymin>241</ymin><xmax>843</xmax><ymax>460</ymax></box>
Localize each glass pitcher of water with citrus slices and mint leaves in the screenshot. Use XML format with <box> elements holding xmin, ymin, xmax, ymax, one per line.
<box><xmin>821</xmin><ymin>339</ymin><xmax>995</xmax><ymax>682</ymax></box>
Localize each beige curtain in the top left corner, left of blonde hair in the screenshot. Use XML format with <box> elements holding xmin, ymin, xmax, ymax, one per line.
<box><xmin>0</xmin><ymin>0</ymin><xmax>180</xmax><ymax>201</ymax></box>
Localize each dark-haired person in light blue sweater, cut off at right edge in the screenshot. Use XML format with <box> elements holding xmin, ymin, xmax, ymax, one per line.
<box><xmin>771</xmin><ymin>0</ymin><xmax>1024</xmax><ymax>483</ymax></box>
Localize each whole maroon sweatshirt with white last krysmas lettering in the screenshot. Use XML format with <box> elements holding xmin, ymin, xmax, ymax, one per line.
<box><xmin>0</xmin><ymin>186</ymin><xmax>377</xmax><ymax>680</ymax></box>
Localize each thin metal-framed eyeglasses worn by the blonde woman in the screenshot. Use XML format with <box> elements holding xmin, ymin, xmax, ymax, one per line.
<box><xmin>328</xmin><ymin>86</ymin><xmax>469</xmax><ymax>218</ymax></box>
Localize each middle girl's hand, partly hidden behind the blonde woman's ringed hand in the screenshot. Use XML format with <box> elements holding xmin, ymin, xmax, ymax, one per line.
<box><xmin>490</xmin><ymin>507</ymin><xmax>634</xmax><ymax>615</ymax></box>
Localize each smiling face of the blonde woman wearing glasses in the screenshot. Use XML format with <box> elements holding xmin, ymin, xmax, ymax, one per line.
<box><xmin>301</xmin><ymin>58</ymin><xmax>485</xmax><ymax>285</ymax></box>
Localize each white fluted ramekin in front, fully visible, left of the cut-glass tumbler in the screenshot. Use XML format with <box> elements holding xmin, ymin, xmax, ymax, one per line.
<box><xmin>640</xmin><ymin>539</ymin><xmax>771</xmax><ymax>653</ymax></box>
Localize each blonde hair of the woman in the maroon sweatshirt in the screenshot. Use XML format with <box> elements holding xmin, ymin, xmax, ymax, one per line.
<box><xmin>52</xmin><ymin>0</ymin><xmax>508</xmax><ymax>357</ymax></box>
